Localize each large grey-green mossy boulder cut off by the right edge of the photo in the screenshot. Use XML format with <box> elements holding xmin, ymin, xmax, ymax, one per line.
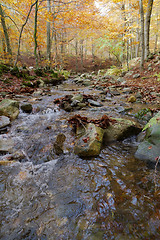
<box><xmin>135</xmin><ymin>112</ymin><xmax>160</xmax><ymax>163</ymax></box>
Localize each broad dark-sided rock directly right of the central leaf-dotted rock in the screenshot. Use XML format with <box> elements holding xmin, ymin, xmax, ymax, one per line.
<box><xmin>104</xmin><ymin>118</ymin><xmax>141</xmax><ymax>144</ymax></box>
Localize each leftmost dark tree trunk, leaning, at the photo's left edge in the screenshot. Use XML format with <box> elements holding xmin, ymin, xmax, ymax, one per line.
<box><xmin>0</xmin><ymin>4</ymin><xmax>12</xmax><ymax>56</ymax></box>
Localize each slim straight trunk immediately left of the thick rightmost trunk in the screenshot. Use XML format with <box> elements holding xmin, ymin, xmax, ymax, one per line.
<box><xmin>139</xmin><ymin>0</ymin><xmax>145</xmax><ymax>69</ymax></box>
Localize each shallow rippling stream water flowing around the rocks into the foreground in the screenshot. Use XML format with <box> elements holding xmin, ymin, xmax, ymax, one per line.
<box><xmin>0</xmin><ymin>79</ymin><xmax>160</xmax><ymax>240</ymax></box>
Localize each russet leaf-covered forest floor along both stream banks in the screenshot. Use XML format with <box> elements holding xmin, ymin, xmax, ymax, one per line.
<box><xmin>0</xmin><ymin>55</ymin><xmax>160</xmax><ymax>108</ymax></box>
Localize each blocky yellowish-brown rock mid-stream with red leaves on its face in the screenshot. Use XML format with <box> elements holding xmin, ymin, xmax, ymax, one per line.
<box><xmin>74</xmin><ymin>123</ymin><xmax>104</xmax><ymax>157</ymax></box>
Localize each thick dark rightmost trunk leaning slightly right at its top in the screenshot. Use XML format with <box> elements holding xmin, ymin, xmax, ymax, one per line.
<box><xmin>145</xmin><ymin>0</ymin><xmax>153</xmax><ymax>58</ymax></box>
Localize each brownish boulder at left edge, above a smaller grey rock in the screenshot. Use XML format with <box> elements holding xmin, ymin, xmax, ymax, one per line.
<box><xmin>0</xmin><ymin>99</ymin><xmax>19</xmax><ymax>120</ymax></box>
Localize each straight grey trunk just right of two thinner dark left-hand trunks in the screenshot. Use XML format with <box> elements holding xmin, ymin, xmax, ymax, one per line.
<box><xmin>47</xmin><ymin>0</ymin><xmax>51</xmax><ymax>62</ymax></box>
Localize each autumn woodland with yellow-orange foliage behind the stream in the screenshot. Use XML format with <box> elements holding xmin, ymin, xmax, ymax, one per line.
<box><xmin>0</xmin><ymin>0</ymin><xmax>160</xmax><ymax>71</ymax></box>
